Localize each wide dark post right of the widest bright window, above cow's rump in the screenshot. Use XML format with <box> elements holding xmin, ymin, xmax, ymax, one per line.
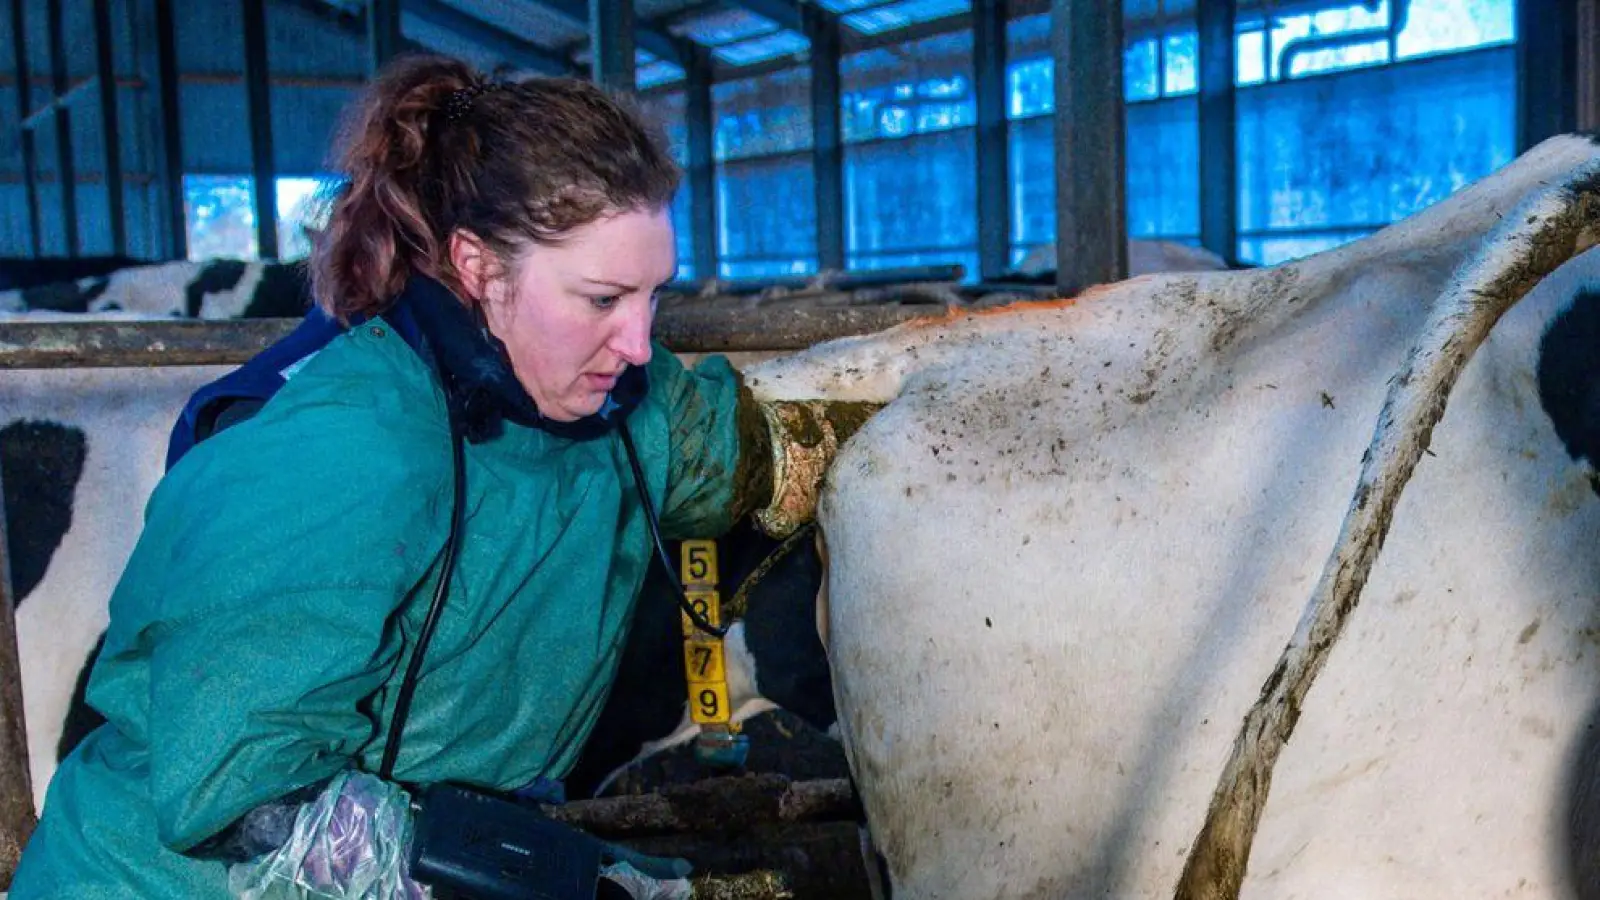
<box><xmin>1517</xmin><ymin>0</ymin><xmax>1578</xmax><ymax>154</ymax></box>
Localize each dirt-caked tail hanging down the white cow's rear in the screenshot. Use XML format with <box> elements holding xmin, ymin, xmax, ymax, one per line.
<box><xmin>1176</xmin><ymin>153</ymin><xmax>1600</xmax><ymax>900</ymax></box>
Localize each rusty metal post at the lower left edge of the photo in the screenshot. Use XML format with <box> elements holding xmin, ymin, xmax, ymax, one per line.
<box><xmin>0</xmin><ymin>464</ymin><xmax>37</xmax><ymax>890</ymax></box>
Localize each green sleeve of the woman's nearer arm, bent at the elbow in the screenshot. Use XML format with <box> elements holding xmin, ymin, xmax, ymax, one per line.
<box><xmin>104</xmin><ymin>350</ymin><xmax>450</xmax><ymax>850</ymax></box>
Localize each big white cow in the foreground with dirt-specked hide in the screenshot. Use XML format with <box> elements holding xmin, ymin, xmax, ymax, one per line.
<box><xmin>732</xmin><ymin>129</ymin><xmax>1600</xmax><ymax>900</ymax></box>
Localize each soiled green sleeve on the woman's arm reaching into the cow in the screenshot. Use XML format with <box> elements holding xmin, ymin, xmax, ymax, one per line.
<box><xmin>650</xmin><ymin>346</ymin><xmax>765</xmax><ymax>540</ymax></box>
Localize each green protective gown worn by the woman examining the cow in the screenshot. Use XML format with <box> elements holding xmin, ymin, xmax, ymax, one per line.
<box><xmin>11</xmin><ymin>320</ymin><xmax>739</xmax><ymax>900</ymax></box>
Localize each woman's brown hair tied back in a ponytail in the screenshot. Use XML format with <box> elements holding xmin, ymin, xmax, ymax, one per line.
<box><xmin>310</xmin><ymin>56</ymin><xmax>680</xmax><ymax>320</ymax></box>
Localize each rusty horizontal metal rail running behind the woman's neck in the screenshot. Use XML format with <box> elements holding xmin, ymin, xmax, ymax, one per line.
<box><xmin>0</xmin><ymin>304</ymin><xmax>947</xmax><ymax>370</ymax></box>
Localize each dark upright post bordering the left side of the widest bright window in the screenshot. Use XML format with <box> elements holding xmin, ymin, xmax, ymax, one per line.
<box><xmin>1198</xmin><ymin>0</ymin><xmax>1238</xmax><ymax>259</ymax></box>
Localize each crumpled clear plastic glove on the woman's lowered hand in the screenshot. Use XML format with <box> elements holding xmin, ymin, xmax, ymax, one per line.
<box><xmin>227</xmin><ymin>772</ymin><xmax>430</xmax><ymax>900</ymax></box>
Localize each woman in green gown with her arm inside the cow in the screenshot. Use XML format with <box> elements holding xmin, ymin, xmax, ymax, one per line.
<box><xmin>11</xmin><ymin>58</ymin><xmax>848</xmax><ymax>900</ymax></box>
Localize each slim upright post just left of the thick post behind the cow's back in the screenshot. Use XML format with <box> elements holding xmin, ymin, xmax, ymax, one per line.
<box><xmin>973</xmin><ymin>0</ymin><xmax>1011</xmax><ymax>279</ymax></box>
